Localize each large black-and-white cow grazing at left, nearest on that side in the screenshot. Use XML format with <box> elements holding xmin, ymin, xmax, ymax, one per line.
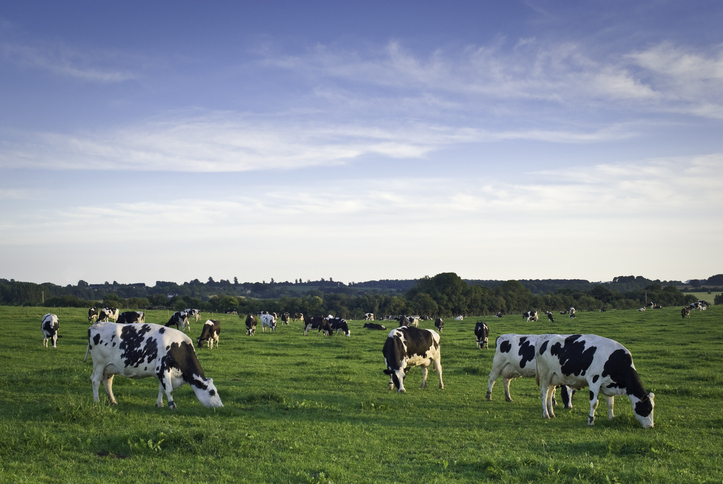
<box><xmin>83</xmin><ymin>322</ymin><xmax>223</xmax><ymax>409</ymax></box>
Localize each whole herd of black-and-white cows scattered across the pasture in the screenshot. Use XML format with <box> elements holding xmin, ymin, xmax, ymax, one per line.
<box><xmin>36</xmin><ymin>301</ymin><xmax>680</xmax><ymax>428</ymax></box>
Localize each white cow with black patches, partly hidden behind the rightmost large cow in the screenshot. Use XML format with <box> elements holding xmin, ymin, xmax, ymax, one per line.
<box><xmin>486</xmin><ymin>334</ymin><xmax>574</xmax><ymax>409</ymax></box>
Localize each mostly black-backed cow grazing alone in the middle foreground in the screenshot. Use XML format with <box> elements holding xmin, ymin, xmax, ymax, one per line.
<box><xmin>382</xmin><ymin>326</ymin><xmax>444</xmax><ymax>392</ymax></box>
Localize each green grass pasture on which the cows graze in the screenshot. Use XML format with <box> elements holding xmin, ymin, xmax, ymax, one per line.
<box><xmin>0</xmin><ymin>308</ymin><xmax>723</xmax><ymax>483</ymax></box>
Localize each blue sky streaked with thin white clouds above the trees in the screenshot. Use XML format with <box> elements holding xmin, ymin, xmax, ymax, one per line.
<box><xmin>0</xmin><ymin>0</ymin><xmax>723</xmax><ymax>285</ymax></box>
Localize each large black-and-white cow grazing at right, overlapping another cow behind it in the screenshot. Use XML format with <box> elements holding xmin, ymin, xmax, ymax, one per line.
<box><xmin>535</xmin><ymin>334</ymin><xmax>655</xmax><ymax>428</ymax></box>
